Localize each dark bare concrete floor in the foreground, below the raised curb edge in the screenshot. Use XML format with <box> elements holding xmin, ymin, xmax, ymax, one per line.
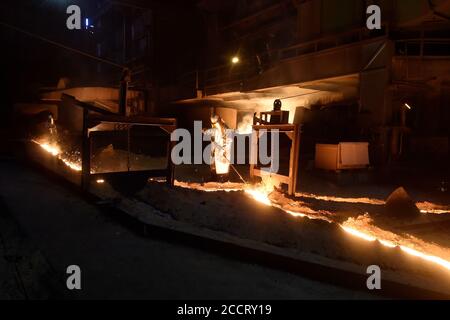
<box><xmin>0</xmin><ymin>159</ymin><xmax>376</xmax><ymax>299</ymax></box>
